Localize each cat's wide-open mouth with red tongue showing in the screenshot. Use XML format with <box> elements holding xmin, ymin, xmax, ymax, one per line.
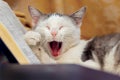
<box><xmin>49</xmin><ymin>41</ymin><xmax>62</xmax><ymax>57</ymax></box>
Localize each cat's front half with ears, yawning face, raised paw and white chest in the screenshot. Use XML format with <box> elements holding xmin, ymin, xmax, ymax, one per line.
<box><xmin>24</xmin><ymin>6</ymin><xmax>98</xmax><ymax>69</ymax></box>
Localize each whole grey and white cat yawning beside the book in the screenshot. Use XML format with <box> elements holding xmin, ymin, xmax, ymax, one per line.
<box><xmin>25</xmin><ymin>6</ymin><xmax>120</xmax><ymax>74</ymax></box>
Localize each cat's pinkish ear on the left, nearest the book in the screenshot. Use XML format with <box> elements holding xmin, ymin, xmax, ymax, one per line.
<box><xmin>28</xmin><ymin>6</ymin><xmax>44</xmax><ymax>27</ymax></box>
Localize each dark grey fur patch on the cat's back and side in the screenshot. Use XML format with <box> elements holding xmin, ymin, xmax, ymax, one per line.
<box><xmin>81</xmin><ymin>33</ymin><xmax>120</xmax><ymax>68</ymax></box>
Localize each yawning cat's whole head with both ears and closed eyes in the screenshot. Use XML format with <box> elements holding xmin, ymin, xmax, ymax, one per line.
<box><xmin>29</xmin><ymin>6</ymin><xmax>86</xmax><ymax>59</ymax></box>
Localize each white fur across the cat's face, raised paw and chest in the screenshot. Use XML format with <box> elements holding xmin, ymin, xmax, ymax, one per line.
<box><xmin>25</xmin><ymin>12</ymin><xmax>98</xmax><ymax>69</ymax></box>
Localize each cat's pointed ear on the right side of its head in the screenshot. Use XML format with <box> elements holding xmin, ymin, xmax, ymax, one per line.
<box><xmin>70</xmin><ymin>7</ymin><xmax>86</xmax><ymax>26</ymax></box>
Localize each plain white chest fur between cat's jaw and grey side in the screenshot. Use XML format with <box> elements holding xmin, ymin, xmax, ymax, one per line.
<box><xmin>57</xmin><ymin>40</ymin><xmax>87</xmax><ymax>64</ymax></box>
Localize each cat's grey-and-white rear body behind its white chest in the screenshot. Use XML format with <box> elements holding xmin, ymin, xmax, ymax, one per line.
<box><xmin>81</xmin><ymin>33</ymin><xmax>120</xmax><ymax>76</ymax></box>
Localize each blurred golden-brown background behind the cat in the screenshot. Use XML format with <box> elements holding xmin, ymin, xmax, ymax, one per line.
<box><xmin>5</xmin><ymin>0</ymin><xmax>120</xmax><ymax>39</ymax></box>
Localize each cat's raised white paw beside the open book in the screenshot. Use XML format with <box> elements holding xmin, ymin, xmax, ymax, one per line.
<box><xmin>24</xmin><ymin>31</ymin><xmax>41</xmax><ymax>46</ymax></box>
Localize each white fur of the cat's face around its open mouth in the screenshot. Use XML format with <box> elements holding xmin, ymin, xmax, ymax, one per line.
<box><xmin>35</xmin><ymin>15</ymin><xmax>80</xmax><ymax>57</ymax></box>
